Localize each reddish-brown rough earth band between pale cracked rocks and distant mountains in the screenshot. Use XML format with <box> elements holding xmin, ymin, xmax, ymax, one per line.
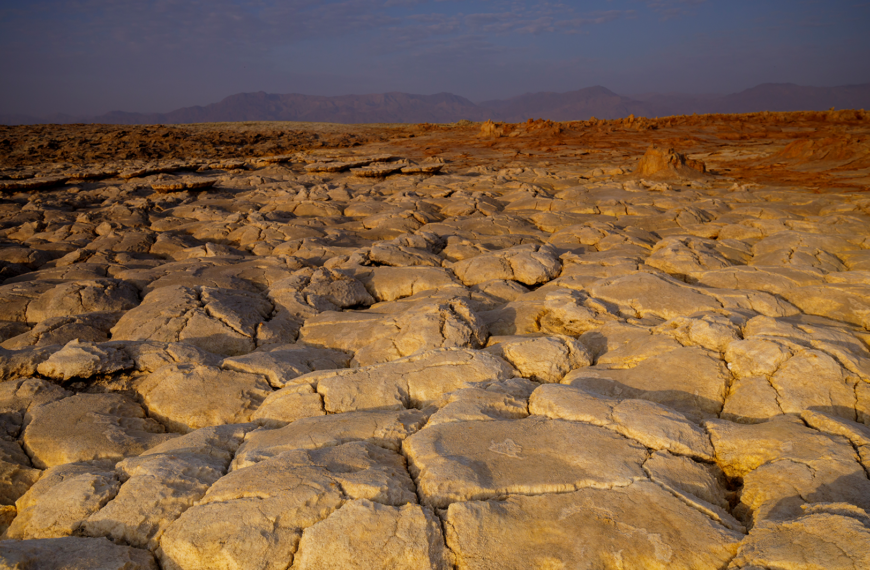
<box><xmin>6</xmin><ymin>110</ymin><xmax>870</xmax><ymax>191</ymax></box>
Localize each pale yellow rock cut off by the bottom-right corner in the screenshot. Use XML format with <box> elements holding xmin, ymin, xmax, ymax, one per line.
<box><xmin>728</xmin><ymin>513</ymin><xmax>870</xmax><ymax>570</ymax></box>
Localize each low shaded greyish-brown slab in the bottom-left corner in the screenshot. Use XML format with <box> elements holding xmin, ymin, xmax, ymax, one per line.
<box><xmin>0</xmin><ymin>536</ymin><xmax>157</xmax><ymax>570</ymax></box>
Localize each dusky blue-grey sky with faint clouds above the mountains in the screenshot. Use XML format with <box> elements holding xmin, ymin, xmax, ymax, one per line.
<box><xmin>0</xmin><ymin>0</ymin><xmax>870</xmax><ymax>116</ymax></box>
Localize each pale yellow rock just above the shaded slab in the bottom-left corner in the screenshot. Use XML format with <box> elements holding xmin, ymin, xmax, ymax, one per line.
<box><xmin>5</xmin><ymin>462</ymin><xmax>121</xmax><ymax>539</ymax></box>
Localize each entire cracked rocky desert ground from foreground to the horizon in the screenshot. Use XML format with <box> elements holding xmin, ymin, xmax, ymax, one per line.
<box><xmin>0</xmin><ymin>111</ymin><xmax>870</xmax><ymax>570</ymax></box>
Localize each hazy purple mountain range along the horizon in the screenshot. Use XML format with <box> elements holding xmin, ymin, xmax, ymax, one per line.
<box><xmin>0</xmin><ymin>83</ymin><xmax>870</xmax><ymax>125</ymax></box>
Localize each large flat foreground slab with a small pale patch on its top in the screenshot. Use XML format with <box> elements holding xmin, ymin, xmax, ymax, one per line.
<box><xmin>402</xmin><ymin>417</ymin><xmax>647</xmax><ymax>508</ymax></box>
